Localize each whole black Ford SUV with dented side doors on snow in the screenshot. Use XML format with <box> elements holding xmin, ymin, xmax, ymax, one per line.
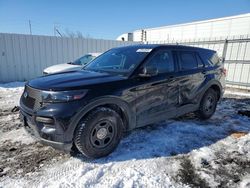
<box><xmin>20</xmin><ymin>45</ymin><xmax>225</xmax><ymax>158</ymax></box>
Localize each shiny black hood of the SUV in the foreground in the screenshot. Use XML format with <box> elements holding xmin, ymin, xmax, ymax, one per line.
<box><xmin>28</xmin><ymin>70</ymin><xmax>125</xmax><ymax>91</ymax></box>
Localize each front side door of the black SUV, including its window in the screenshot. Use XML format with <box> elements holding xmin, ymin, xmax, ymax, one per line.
<box><xmin>133</xmin><ymin>49</ymin><xmax>179</xmax><ymax>126</ymax></box>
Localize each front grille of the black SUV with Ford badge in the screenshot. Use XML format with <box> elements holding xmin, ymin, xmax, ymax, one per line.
<box><xmin>22</xmin><ymin>85</ymin><xmax>42</xmax><ymax>110</ymax></box>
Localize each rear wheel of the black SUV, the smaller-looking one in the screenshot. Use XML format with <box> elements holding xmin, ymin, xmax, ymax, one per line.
<box><xmin>198</xmin><ymin>88</ymin><xmax>218</xmax><ymax>119</ymax></box>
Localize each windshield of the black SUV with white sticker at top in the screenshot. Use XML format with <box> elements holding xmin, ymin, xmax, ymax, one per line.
<box><xmin>84</xmin><ymin>47</ymin><xmax>151</xmax><ymax>74</ymax></box>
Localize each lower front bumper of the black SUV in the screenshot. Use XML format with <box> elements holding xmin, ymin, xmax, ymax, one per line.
<box><xmin>20</xmin><ymin>108</ymin><xmax>72</xmax><ymax>152</ymax></box>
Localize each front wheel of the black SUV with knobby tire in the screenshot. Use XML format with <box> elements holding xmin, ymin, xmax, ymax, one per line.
<box><xmin>74</xmin><ymin>107</ymin><xmax>123</xmax><ymax>158</ymax></box>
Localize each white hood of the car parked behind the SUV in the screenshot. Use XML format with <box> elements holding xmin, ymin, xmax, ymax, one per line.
<box><xmin>43</xmin><ymin>63</ymin><xmax>82</xmax><ymax>74</ymax></box>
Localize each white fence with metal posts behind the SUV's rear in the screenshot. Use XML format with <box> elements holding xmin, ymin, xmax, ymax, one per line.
<box><xmin>146</xmin><ymin>36</ymin><xmax>250</xmax><ymax>89</ymax></box>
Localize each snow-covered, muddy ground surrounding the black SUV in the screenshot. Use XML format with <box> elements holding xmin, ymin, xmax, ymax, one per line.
<box><xmin>0</xmin><ymin>83</ymin><xmax>250</xmax><ymax>187</ymax></box>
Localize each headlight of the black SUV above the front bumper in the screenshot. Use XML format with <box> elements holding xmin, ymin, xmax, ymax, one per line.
<box><xmin>42</xmin><ymin>90</ymin><xmax>87</xmax><ymax>103</ymax></box>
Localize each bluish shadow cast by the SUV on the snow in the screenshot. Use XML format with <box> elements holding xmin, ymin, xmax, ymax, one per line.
<box><xmin>77</xmin><ymin>98</ymin><xmax>250</xmax><ymax>164</ymax></box>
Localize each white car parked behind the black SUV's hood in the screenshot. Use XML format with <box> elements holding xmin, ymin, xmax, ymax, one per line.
<box><xmin>43</xmin><ymin>53</ymin><xmax>102</xmax><ymax>75</ymax></box>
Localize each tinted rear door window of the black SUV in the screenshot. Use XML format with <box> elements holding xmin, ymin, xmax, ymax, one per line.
<box><xmin>179</xmin><ymin>52</ymin><xmax>198</xmax><ymax>70</ymax></box>
